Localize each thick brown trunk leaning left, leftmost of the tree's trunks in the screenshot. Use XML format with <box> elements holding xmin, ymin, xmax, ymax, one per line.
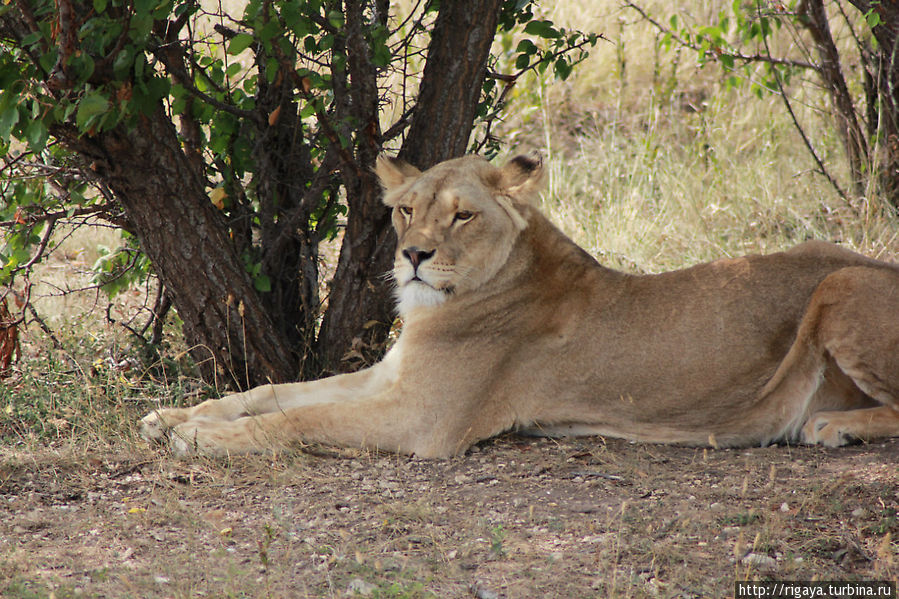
<box><xmin>53</xmin><ymin>108</ymin><xmax>297</xmax><ymax>388</ymax></box>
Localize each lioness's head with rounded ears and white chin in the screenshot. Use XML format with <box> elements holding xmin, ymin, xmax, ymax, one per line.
<box><xmin>377</xmin><ymin>155</ymin><xmax>543</xmax><ymax>315</ymax></box>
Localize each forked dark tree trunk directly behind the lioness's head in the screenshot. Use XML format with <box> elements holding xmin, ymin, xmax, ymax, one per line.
<box><xmin>319</xmin><ymin>0</ymin><xmax>502</xmax><ymax>371</ymax></box>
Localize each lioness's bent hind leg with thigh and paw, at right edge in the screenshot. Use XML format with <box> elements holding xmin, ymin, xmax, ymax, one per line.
<box><xmin>802</xmin><ymin>267</ymin><xmax>899</xmax><ymax>447</ymax></box>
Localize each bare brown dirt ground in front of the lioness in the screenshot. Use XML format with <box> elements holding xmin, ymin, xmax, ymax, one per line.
<box><xmin>0</xmin><ymin>436</ymin><xmax>899</xmax><ymax>599</ymax></box>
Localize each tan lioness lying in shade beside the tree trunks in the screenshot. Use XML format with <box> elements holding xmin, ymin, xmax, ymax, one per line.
<box><xmin>142</xmin><ymin>156</ymin><xmax>899</xmax><ymax>457</ymax></box>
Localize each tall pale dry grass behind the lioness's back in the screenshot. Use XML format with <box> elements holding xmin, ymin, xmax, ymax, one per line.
<box><xmin>503</xmin><ymin>0</ymin><xmax>899</xmax><ymax>272</ymax></box>
